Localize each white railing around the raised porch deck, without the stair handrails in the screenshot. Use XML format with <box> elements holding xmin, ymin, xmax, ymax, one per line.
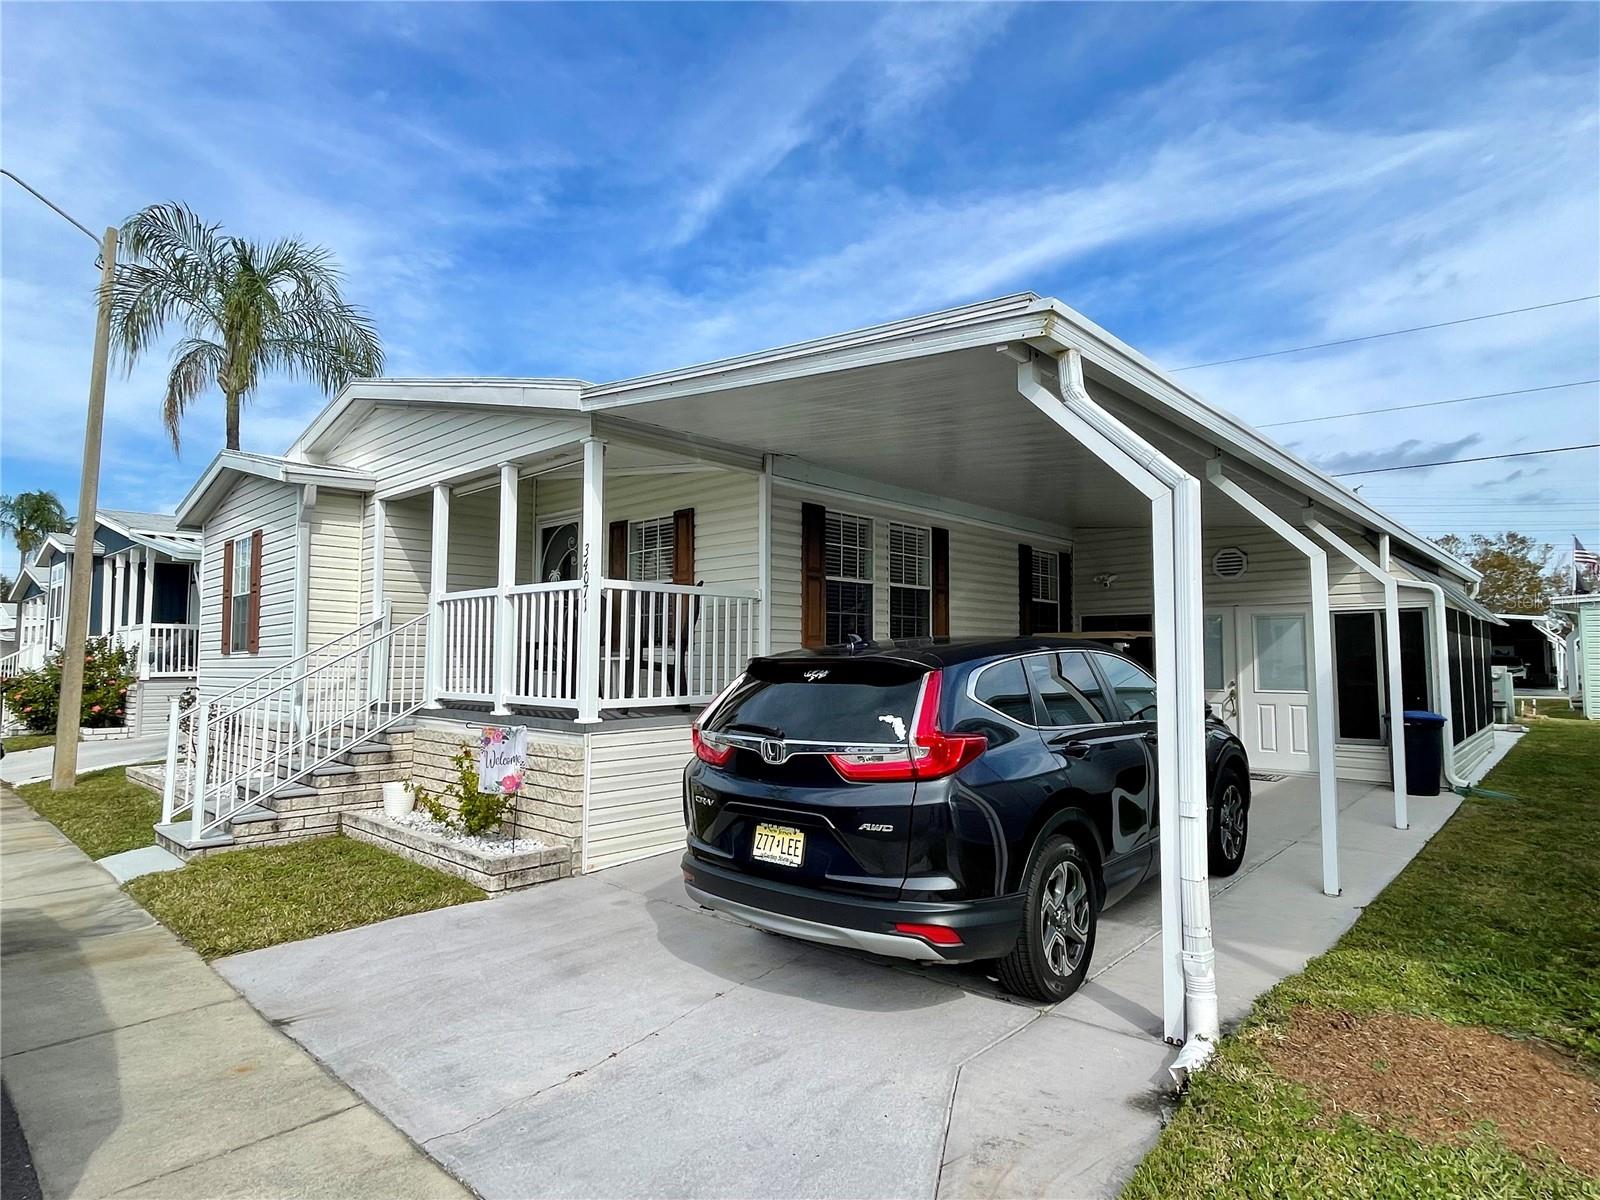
<box><xmin>437</xmin><ymin>579</ymin><xmax>760</xmax><ymax>709</ymax></box>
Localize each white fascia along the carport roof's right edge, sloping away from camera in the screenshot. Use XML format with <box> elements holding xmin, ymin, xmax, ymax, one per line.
<box><xmin>1024</xmin><ymin>299</ymin><xmax>1483</xmax><ymax>582</ymax></box>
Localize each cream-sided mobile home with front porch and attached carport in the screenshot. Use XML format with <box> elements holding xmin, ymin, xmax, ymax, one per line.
<box><xmin>168</xmin><ymin>294</ymin><xmax>1498</xmax><ymax>890</ymax></box>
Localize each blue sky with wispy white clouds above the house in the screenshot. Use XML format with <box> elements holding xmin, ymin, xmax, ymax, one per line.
<box><xmin>0</xmin><ymin>3</ymin><xmax>1600</xmax><ymax>582</ymax></box>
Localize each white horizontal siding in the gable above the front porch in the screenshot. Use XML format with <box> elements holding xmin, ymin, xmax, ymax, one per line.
<box><xmin>328</xmin><ymin>405</ymin><xmax>589</xmax><ymax>496</ymax></box>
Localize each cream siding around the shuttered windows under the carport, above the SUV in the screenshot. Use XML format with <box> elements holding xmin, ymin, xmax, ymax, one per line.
<box><xmin>770</xmin><ymin>485</ymin><xmax>1082</xmax><ymax>653</ymax></box>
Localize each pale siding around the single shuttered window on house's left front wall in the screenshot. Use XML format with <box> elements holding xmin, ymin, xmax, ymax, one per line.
<box><xmin>200</xmin><ymin>475</ymin><xmax>298</xmax><ymax>696</ymax></box>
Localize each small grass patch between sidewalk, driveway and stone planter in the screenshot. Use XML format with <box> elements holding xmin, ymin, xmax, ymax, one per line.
<box><xmin>128</xmin><ymin>837</ymin><xmax>483</xmax><ymax>958</ymax></box>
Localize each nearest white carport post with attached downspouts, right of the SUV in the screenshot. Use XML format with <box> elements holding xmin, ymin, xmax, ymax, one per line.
<box><xmin>1016</xmin><ymin>347</ymin><xmax>1218</xmax><ymax>1064</ymax></box>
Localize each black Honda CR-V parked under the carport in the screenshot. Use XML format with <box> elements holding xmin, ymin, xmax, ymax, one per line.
<box><xmin>683</xmin><ymin>640</ymin><xmax>1250</xmax><ymax>1000</ymax></box>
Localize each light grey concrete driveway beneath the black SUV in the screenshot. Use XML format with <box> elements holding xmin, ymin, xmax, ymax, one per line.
<box><xmin>218</xmin><ymin>779</ymin><xmax>1456</xmax><ymax>1200</ymax></box>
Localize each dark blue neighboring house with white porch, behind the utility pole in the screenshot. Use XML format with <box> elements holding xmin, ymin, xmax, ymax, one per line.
<box><xmin>0</xmin><ymin>509</ymin><xmax>200</xmax><ymax>733</ymax></box>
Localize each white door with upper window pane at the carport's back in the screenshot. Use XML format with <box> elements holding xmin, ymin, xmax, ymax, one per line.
<box><xmin>1238</xmin><ymin>608</ymin><xmax>1312</xmax><ymax>771</ymax></box>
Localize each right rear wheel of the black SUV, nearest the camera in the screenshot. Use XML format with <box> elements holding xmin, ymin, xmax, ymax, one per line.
<box><xmin>998</xmin><ymin>834</ymin><xmax>1101</xmax><ymax>1003</ymax></box>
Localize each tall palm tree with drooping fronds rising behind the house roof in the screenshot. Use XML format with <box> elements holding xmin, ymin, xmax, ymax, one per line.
<box><xmin>112</xmin><ymin>203</ymin><xmax>384</xmax><ymax>450</ymax></box>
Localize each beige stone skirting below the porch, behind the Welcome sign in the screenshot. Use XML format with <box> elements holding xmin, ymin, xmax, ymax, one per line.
<box><xmin>411</xmin><ymin>714</ymin><xmax>584</xmax><ymax>858</ymax></box>
